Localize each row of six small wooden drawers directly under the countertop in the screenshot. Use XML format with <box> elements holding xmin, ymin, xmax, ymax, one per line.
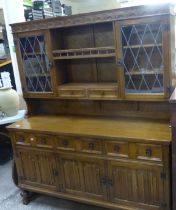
<box><xmin>14</xmin><ymin>133</ymin><xmax>163</xmax><ymax>161</ymax></box>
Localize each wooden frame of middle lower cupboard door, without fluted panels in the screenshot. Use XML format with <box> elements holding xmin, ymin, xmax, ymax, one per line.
<box><xmin>59</xmin><ymin>153</ymin><xmax>108</xmax><ymax>201</ymax></box>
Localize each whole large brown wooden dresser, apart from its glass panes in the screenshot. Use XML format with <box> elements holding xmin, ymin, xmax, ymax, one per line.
<box><xmin>8</xmin><ymin>4</ymin><xmax>176</xmax><ymax>210</ymax></box>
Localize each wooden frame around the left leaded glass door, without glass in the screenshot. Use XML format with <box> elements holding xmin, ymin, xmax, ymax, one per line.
<box><xmin>14</xmin><ymin>30</ymin><xmax>57</xmax><ymax>98</ymax></box>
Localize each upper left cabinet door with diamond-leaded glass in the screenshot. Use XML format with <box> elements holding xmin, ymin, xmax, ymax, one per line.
<box><xmin>18</xmin><ymin>32</ymin><xmax>53</xmax><ymax>96</ymax></box>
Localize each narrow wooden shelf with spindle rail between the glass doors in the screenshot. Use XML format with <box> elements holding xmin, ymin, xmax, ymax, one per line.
<box><xmin>53</xmin><ymin>47</ymin><xmax>115</xmax><ymax>60</ymax></box>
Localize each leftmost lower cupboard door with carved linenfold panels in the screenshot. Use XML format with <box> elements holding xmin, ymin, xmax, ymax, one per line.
<box><xmin>15</xmin><ymin>148</ymin><xmax>60</xmax><ymax>191</ymax></box>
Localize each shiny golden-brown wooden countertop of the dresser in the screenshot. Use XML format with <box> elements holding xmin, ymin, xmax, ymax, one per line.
<box><xmin>8</xmin><ymin>116</ymin><xmax>171</xmax><ymax>142</ymax></box>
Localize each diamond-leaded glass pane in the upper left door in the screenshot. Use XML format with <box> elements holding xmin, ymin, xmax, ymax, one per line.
<box><xmin>19</xmin><ymin>36</ymin><xmax>52</xmax><ymax>92</ymax></box>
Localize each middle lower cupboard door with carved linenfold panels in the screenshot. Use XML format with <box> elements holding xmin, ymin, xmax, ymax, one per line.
<box><xmin>61</xmin><ymin>155</ymin><xmax>107</xmax><ymax>200</ymax></box>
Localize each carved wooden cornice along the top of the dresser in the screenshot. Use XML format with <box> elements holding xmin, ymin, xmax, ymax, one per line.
<box><xmin>11</xmin><ymin>4</ymin><xmax>174</xmax><ymax>33</ymax></box>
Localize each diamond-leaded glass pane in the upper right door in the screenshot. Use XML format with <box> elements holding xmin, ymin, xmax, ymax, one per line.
<box><xmin>121</xmin><ymin>23</ymin><xmax>164</xmax><ymax>94</ymax></box>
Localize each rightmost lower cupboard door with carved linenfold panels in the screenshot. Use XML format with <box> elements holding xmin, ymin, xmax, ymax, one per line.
<box><xmin>109</xmin><ymin>161</ymin><xmax>169</xmax><ymax>210</ymax></box>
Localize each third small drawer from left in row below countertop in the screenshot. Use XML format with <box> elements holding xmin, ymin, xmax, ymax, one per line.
<box><xmin>56</xmin><ymin>137</ymin><xmax>76</xmax><ymax>151</ymax></box>
